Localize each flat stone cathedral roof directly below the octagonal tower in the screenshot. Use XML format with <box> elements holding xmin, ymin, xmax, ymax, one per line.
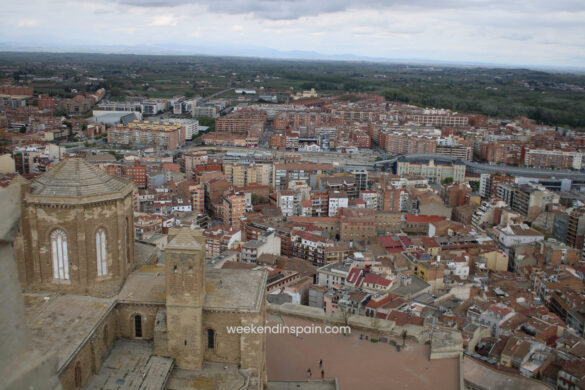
<box><xmin>25</xmin><ymin>294</ymin><xmax>115</xmax><ymax>372</ymax></box>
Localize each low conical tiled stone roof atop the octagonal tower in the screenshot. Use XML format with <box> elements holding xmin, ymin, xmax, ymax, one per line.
<box><xmin>29</xmin><ymin>158</ymin><xmax>133</xmax><ymax>200</ymax></box>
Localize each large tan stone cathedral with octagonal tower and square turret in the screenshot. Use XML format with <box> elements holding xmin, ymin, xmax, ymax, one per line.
<box><xmin>0</xmin><ymin>158</ymin><xmax>267</xmax><ymax>389</ymax></box>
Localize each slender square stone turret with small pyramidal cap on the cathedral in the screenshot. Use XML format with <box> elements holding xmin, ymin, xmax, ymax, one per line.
<box><xmin>165</xmin><ymin>229</ymin><xmax>205</xmax><ymax>369</ymax></box>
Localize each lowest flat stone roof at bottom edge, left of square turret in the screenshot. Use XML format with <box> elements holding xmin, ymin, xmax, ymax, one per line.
<box><xmin>83</xmin><ymin>340</ymin><xmax>174</xmax><ymax>390</ymax></box>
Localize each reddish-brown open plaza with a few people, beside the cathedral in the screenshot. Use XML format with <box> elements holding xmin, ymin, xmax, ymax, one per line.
<box><xmin>266</xmin><ymin>316</ymin><xmax>459</xmax><ymax>390</ymax></box>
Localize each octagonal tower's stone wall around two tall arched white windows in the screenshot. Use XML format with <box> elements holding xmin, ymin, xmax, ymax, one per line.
<box><xmin>15</xmin><ymin>195</ymin><xmax>134</xmax><ymax>296</ymax></box>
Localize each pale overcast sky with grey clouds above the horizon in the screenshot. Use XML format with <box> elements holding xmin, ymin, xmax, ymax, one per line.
<box><xmin>0</xmin><ymin>0</ymin><xmax>585</xmax><ymax>68</ymax></box>
